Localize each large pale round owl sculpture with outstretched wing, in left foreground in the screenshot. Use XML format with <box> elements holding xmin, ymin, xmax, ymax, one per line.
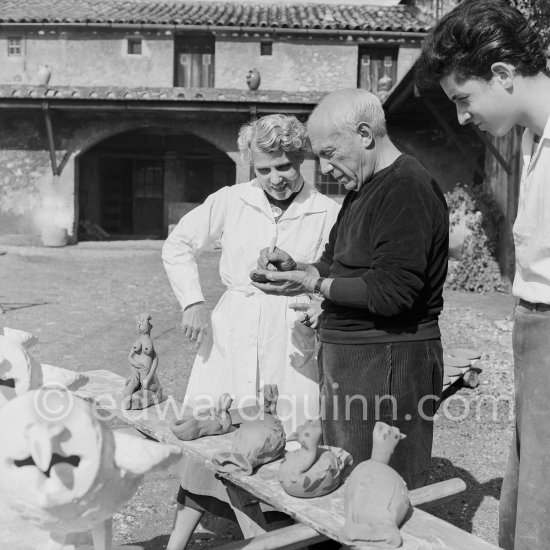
<box><xmin>0</xmin><ymin>388</ymin><xmax>181</xmax><ymax>550</ymax></box>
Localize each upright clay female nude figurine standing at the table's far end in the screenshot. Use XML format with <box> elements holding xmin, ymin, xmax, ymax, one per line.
<box><xmin>122</xmin><ymin>313</ymin><xmax>164</xmax><ymax>409</ymax></box>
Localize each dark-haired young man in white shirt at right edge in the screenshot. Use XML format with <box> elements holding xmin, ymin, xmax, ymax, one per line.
<box><xmin>417</xmin><ymin>0</ymin><xmax>550</xmax><ymax>550</ymax></box>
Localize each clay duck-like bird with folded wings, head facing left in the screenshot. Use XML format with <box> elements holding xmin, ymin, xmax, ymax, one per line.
<box><xmin>279</xmin><ymin>419</ymin><xmax>352</xmax><ymax>498</ymax></box>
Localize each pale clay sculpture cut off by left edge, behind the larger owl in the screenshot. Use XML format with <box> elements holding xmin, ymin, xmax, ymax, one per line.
<box><xmin>0</xmin><ymin>327</ymin><xmax>43</xmax><ymax>408</ymax></box>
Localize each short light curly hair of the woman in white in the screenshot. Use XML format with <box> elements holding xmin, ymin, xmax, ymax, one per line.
<box><xmin>238</xmin><ymin>114</ymin><xmax>309</xmax><ymax>164</ymax></box>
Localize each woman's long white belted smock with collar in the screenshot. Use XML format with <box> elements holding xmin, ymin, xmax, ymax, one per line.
<box><xmin>162</xmin><ymin>180</ymin><xmax>340</xmax><ymax>436</ymax></box>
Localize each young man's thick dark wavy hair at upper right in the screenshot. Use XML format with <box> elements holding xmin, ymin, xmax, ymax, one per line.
<box><xmin>416</xmin><ymin>0</ymin><xmax>546</xmax><ymax>89</ymax></box>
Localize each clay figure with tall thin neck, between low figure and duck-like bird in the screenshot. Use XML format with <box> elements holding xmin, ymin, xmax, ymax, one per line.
<box><xmin>212</xmin><ymin>385</ymin><xmax>286</xmax><ymax>475</ymax></box>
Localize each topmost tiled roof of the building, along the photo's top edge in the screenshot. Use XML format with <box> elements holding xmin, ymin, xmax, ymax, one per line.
<box><xmin>0</xmin><ymin>0</ymin><xmax>433</xmax><ymax>32</ymax></box>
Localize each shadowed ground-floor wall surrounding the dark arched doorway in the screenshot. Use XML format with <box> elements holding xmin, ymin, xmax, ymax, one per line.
<box><xmin>0</xmin><ymin>112</ymin><xmax>248</xmax><ymax>244</ymax></box>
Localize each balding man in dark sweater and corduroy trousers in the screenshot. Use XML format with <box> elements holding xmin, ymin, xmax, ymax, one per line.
<box><xmin>251</xmin><ymin>89</ymin><xmax>449</xmax><ymax>489</ymax></box>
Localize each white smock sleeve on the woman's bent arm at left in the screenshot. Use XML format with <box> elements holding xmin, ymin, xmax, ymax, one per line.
<box><xmin>162</xmin><ymin>187</ymin><xmax>229</xmax><ymax>310</ymax></box>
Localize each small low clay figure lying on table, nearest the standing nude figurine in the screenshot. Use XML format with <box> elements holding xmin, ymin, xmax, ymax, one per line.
<box><xmin>170</xmin><ymin>393</ymin><xmax>233</xmax><ymax>441</ymax></box>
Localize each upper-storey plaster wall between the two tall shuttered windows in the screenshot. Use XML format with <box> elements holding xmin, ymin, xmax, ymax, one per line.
<box><xmin>215</xmin><ymin>38</ymin><xmax>358</xmax><ymax>92</ymax></box>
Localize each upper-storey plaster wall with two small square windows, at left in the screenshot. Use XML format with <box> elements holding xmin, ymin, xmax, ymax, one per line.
<box><xmin>0</xmin><ymin>29</ymin><xmax>174</xmax><ymax>87</ymax></box>
